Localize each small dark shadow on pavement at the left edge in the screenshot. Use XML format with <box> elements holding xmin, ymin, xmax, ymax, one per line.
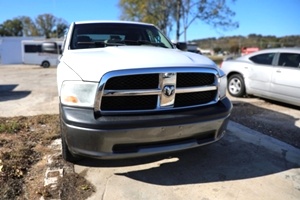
<box><xmin>0</xmin><ymin>84</ymin><xmax>31</xmax><ymax>101</ymax></box>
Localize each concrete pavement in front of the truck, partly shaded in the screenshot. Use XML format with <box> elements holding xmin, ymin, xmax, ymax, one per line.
<box><xmin>75</xmin><ymin>123</ymin><xmax>300</xmax><ymax>200</ymax></box>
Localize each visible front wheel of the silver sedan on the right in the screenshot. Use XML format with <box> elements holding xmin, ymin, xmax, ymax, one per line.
<box><xmin>227</xmin><ymin>74</ymin><xmax>245</xmax><ymax>97</ymax></box>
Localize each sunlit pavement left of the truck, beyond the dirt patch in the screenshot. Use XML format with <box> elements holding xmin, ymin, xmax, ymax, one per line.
<box><xmin>0</xmin><ymin>65</ymin><xmax>58</xmax><ymax>117</ymax></box>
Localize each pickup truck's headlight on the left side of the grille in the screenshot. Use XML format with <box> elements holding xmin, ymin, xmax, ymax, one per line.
<box><xmin>60</xmin><ymin>81</ymin><xmax>98</xmax><ymax>107</ymax></box>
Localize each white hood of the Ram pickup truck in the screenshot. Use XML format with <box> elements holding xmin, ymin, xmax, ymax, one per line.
<box><xmin>60</xmin><ymin>46</ymin><xmax>215</xmax><ymax>82</ymax></box>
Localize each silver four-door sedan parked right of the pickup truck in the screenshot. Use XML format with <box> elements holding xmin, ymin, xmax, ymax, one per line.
<box><xmin>221</xmin><ymin>48</ymin><xmax>300</xmax><ymax>106</ymax></box>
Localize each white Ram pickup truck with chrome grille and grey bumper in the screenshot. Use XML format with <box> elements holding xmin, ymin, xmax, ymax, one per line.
<box><xmin>57</xmin><ymin>21</ymin><xmax>232</xmax><ymax>162</ymax></box>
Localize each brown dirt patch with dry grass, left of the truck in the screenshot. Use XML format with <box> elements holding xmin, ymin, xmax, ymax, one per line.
<box><xmin>0</xmin><ymin>115</ymin><xmax>93</xmax><ymax>200</ymax></box>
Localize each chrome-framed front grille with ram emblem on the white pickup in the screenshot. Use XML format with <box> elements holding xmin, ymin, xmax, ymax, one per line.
<box><xmin>95</xmin><ymin>67</ymin><xmax>218</xmax><ymax>114</ymax></box>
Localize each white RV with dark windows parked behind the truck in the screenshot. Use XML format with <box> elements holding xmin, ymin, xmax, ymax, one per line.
<box><xmin>22</xmin><ymin>40</ymin><xmax>63</xmax><ymax>68</ymax></box>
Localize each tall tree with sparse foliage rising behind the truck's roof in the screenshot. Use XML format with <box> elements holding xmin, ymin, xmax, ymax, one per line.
<box><xmin>119</xmin><ymin>0</ymin><xmax>239</xmax><ymax>41</ymax></box>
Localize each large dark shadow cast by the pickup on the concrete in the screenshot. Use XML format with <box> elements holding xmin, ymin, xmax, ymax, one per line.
<box><xmin>78</xmin><ymin>132</ymin><xmax>300</xmax><ymax>186</ymax></box>
